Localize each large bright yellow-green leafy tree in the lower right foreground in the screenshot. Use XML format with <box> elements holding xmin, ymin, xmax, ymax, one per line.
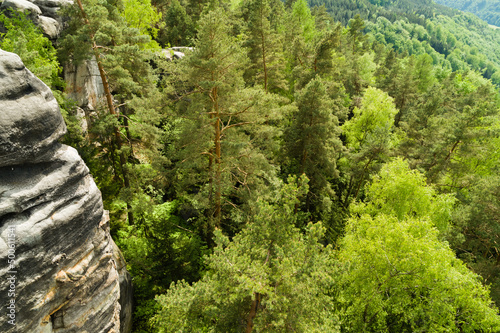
<box><xmin>336</xmin><ymin>159</ymin><xmax>500</xmax><ymax>332</ymax></box>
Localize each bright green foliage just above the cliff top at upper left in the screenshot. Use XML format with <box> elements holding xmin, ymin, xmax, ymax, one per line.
<box><xmin>0</xmin><ymin>11</ymin><xmax>61</xmax><ymax>88</ymax></box>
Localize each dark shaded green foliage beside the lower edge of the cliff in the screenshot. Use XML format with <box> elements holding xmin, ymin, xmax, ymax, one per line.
<box><xmin>118</xmin><ymin>202</ymin><xmax>206</xmax><ymax>332</ymax></box>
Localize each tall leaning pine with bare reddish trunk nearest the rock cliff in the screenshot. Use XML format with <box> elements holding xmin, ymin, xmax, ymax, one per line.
<box><xmin>60</xmin><ymin>0</ymin><xmax>157</xmax><ymax>224</ymax></box>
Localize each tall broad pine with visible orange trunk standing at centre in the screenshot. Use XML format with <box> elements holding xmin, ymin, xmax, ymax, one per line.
<box><xmin>168</xmin><ymin>8</ymin><xmax>286</xmax><ymax>239</ymax></box>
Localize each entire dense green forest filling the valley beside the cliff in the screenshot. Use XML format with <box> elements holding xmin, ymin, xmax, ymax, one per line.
<box><xmin>0</xmin><ymin>0</ymin><xmax>500</xmax><ymax>332</ymax></box>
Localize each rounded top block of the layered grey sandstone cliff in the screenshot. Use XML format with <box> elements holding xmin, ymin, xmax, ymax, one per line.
<box><xmin>0</xmin><ymin>50</ymin><xmax>66</xmax><ymax>167</ymax></box>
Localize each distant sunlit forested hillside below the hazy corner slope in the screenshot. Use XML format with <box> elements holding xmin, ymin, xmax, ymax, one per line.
<box><xmin>310</xmin><ymin>0</ymin><xmax>500</xmax><ymax>85</ymax></box>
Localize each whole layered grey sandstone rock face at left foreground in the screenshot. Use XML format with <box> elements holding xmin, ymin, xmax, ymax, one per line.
<box><xmin>0</xmin><ymin>50</ymin><xmax>131</xmax><ymax>333</ymax></box>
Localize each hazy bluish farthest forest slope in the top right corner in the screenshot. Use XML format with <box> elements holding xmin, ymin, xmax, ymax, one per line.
<box><xmin>436</xmin><ymin>0</ymin><xmax>500</xmax><ymax>27</ymax></box>
